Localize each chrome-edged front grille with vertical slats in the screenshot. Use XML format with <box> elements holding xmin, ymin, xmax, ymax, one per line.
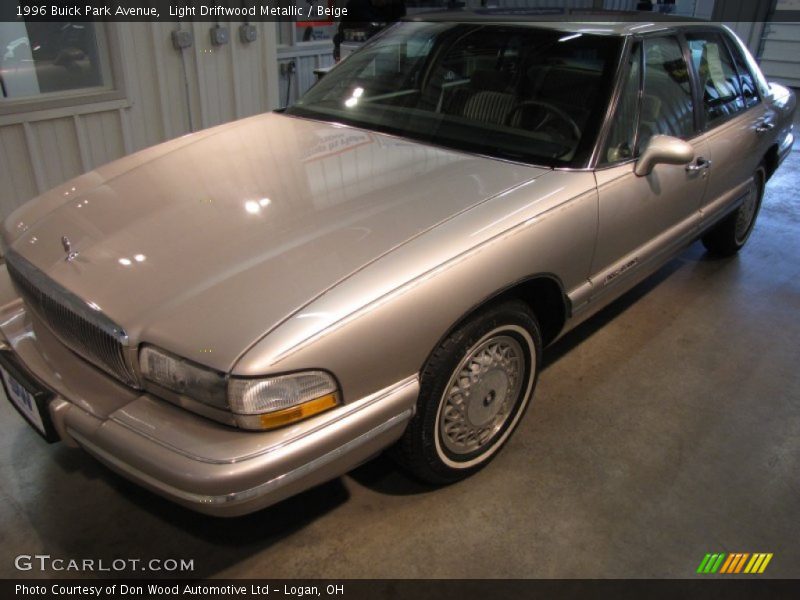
<box><xmin>6</xmin><ymin>249</ymin><xmax>139</xmax><ymax>387</ymax></box>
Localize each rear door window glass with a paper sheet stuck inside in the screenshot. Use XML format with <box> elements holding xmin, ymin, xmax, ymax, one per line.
<box><xmin>687</xmin><ymin>33</ymin><xmax>745</xmax><ymax>126</ymax></box>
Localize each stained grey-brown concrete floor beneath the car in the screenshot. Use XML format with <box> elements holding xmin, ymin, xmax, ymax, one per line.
<box><xmin>0</xmin><ymin>143</ymin><xmax>800</xmax><ymax>578</ymax></box>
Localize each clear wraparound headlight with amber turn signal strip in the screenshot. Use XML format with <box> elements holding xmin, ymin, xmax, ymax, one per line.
<box><xmin>139</xmin><ymin>346</ymin><xmax>340</xmax><ymax>429</ymax></box>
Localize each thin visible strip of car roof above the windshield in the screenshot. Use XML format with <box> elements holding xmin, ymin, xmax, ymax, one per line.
<box><xmin>404</xmin><ymin>8</ymin><xmax>710</xmax><ymax>35</ymax></box>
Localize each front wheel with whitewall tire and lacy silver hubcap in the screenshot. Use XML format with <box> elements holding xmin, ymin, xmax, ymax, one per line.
<box><xmin>394</xmin><ymin>300</ymin><xmax>542</xmax><ymax>484</ymax></box>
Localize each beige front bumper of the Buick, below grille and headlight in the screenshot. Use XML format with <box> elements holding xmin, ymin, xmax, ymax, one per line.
<box><xmin>0</xmin><ymin>268</ymin><xmax>419</xmax><ymax>516</ymax></box>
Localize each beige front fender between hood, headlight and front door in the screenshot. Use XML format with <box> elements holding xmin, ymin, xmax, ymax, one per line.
<box><xmin>233</xmin><ymin>172</ymin><xmax>597</xmax><ymax>402</ymax></box>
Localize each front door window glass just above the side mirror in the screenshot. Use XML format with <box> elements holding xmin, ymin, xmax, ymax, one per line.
<box><xmin>639</xmin><ymin>37</ymin><xmax>695</xmax><ymax>148</ymax></box>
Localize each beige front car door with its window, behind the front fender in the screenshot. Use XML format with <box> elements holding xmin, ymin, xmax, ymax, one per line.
<box><xmin>590</xmin><ymin>35</ymin><xmax>708</xmax><ymax>300</ymax></box>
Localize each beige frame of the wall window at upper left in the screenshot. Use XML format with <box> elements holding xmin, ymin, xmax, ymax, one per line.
<box><xmin>0</xmin><ymin>21</ymin><xmax>127</xmax><ymax>116</ymax></box>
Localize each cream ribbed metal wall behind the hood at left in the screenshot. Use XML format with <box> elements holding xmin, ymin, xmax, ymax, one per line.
<box><xmin>0</xmin><ymin>23</ymin><xmax>280</xmax><ymax>224</ymax></box>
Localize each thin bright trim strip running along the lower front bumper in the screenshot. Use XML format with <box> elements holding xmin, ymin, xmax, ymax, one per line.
<box><xmin>67</xmin><ymin>409</ymin><xmax>412</xmax><ymax>505</ymax></box>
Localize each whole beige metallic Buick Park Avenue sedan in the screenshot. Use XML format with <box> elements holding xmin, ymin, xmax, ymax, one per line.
<box><xmin>0</xmin><ymin>12</ymin><xmax>795</xmax><ymax>516</ymax></box>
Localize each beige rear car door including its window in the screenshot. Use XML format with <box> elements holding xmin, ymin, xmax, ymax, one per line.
<box><xmin>686</xmin><ymin>31</ymin><xmax>774</xmax><ymax>227</ymax></box>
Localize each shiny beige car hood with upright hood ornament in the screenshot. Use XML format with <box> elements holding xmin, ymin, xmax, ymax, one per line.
<box><xmin>5</xmin><ymin>114</ymin><xmax>546</xmax><ymax>370</ymax></box>
